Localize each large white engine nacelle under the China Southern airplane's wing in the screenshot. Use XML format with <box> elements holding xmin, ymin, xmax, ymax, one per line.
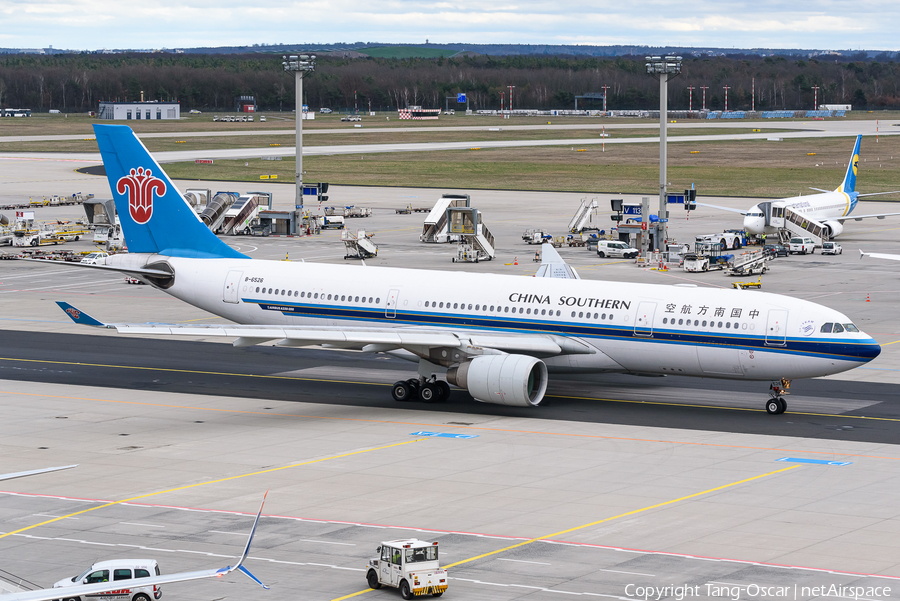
<box><xmin>447</xmin><ymin>355</ymin><xmax>547</xmax><ymax>407</ymax></box>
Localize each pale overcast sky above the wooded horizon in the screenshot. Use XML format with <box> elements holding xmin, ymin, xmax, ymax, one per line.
<box><xmin>0</xmin><ymin>0</ymin><xmax>900</xmax><ymax>50</ymax></box>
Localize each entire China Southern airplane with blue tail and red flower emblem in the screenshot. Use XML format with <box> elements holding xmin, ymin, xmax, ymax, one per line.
<box><xmin>45</xmin><ymin>125</ymin><xmax>881</xmax><ymax>413</ymax></box>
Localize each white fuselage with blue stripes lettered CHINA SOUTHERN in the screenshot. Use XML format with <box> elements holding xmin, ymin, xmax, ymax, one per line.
<box><xmin>116</xmin><ymin>254</ymin><xmax>880</xmax><ymax>380</ymax></box>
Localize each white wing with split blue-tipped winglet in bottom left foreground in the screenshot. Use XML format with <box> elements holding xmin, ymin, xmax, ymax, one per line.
<box><xmin>0</xmin><ymin>491</ymin><xmax>269</xmax><ymax>601</ymax></box>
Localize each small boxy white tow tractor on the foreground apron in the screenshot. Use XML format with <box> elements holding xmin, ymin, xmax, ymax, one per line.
<box><xmin>366</xmin><ymin>538</ymin><xmax>447</xmax><ymax>599</ymax></box>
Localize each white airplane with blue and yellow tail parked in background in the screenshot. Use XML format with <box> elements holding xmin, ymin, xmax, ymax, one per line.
<box><xmin>696</xmin><ymin>136</ymin><xmax>900</xmax><ymax>239</ymax></box>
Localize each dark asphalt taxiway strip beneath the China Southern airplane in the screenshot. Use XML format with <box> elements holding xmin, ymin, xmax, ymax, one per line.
<box><xmin>0</xmin><ymin>330</ymin><xmax>900</xmax><ymax>444</ymax></box>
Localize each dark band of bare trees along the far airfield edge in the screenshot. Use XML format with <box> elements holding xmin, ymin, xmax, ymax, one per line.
<box><xmin>0</xmin><ymin>53</ymin><xmax>900</xmax><ymax>112</ymax></box>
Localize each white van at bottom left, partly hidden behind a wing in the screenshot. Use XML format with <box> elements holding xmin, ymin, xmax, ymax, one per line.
<box><xmin>53</xmin><ymin>559</ymin><xmax>162</xmax><ymax>601</ymax></box>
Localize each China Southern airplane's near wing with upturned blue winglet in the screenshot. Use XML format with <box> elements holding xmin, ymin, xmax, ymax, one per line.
<box><xmin>54</xmin><ymin>302</ymin><xmax>596</xmax><ymax>356</ymax></box>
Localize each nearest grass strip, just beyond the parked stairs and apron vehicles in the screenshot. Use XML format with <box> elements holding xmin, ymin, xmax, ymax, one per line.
<box><xmin>165</xmin><ymin>136</ymin><xmax>900</xmax><ymax>200</ymax></box>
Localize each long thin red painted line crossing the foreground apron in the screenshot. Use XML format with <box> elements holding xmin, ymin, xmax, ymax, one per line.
<box><xmin>0</xmin><ymin>491</ymin><xmax>900</xmax><ymax>580</ymax></box>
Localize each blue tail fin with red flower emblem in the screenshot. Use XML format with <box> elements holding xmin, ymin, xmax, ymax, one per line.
<box><xmin>94</xmin><ymin>125</ymin><xmax>248</xmax><ymax>259</ymax></box>
